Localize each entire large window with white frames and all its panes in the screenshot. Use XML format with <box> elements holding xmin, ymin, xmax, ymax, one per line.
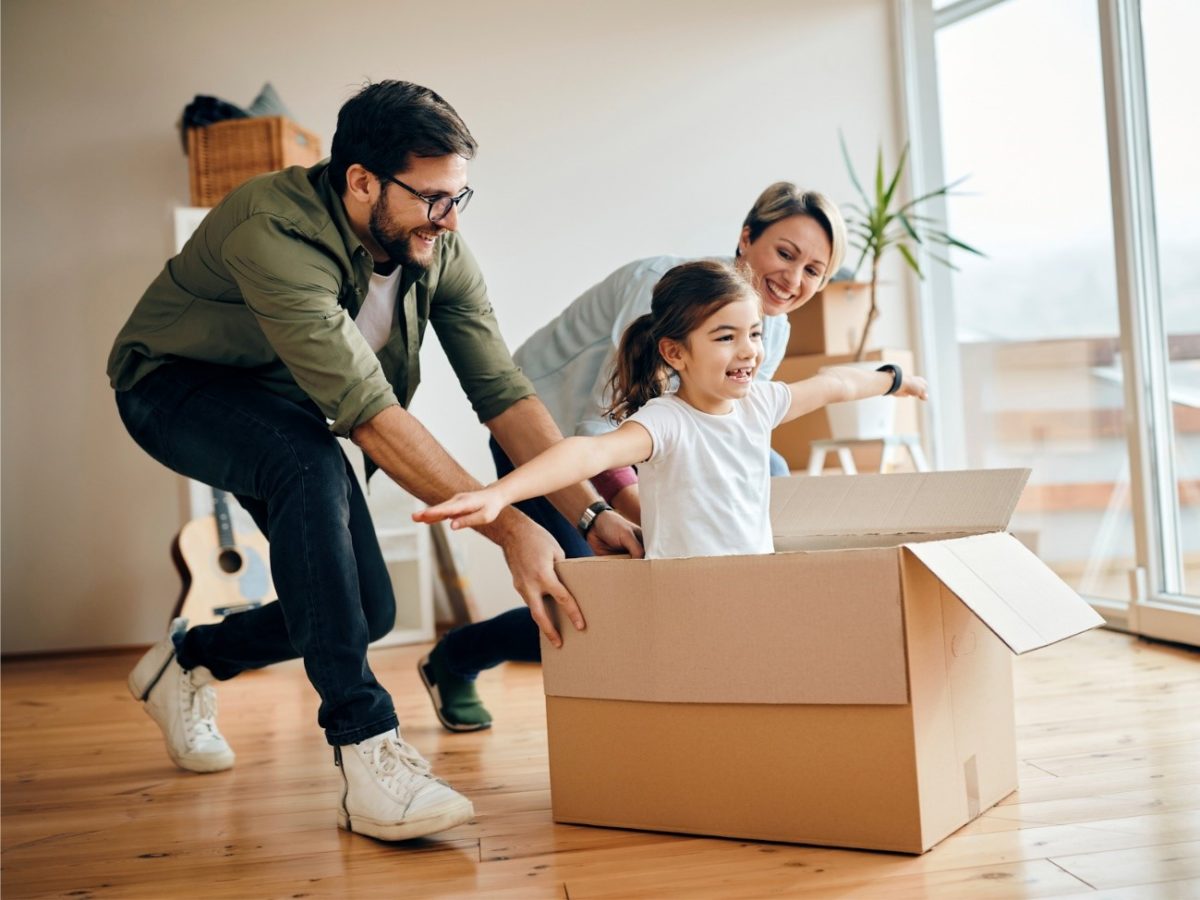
<box><xmin>901</xmin><ymin>0</ymin><xmax>1200</xmax><ymax>643</ymax></box>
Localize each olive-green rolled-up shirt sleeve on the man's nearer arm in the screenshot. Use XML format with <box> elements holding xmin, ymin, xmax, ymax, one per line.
<box><xmin>222</xmin><ymin>214</ymin><xmax>398</xmax><ymax>436</ymax></box>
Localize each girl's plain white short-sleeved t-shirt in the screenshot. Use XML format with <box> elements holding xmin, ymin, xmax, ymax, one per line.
<box><xmin>628</xmin><ymin>382</ymin><xmax>792</xmax><ymax>559</ymax></box>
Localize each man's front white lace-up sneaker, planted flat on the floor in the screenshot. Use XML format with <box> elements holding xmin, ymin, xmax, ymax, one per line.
<box><xmin>335</xmin><ymin>731</ymin><xmax>475</xmax><ymax>841</ymax></box>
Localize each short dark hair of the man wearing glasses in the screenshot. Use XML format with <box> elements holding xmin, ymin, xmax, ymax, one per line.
<box><xmin>329</xmin><ymin>80</ymin><xmax>478</xmax><ymax>193</ymax></box>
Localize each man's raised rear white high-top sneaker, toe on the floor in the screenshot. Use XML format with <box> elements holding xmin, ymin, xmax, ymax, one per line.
<box><xmin>130</xmin><ymin>619</ymin><xmax>234</xmax><ymax>772</ymax></box>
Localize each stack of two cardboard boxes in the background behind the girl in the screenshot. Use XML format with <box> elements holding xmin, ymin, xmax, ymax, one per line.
<box><xmin>772</xmin><ymin>281</ymin><xmax>918</xmax><ymax>472</ymax></box>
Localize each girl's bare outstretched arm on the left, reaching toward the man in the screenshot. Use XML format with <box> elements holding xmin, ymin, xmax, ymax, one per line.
<box><xmin>413</xmin><ymin>422</ymin><xmax>654</xmax><ymax>528</ymax></box>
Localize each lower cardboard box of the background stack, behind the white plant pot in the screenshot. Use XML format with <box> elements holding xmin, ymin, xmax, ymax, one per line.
<box><xmin>770</xmin><ymin>349</ymin><xmax>919</xmax><ymax>472</ymax></box>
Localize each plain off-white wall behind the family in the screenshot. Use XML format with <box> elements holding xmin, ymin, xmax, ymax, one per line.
<box><xmin>0</xmin><ymin>0</ymin><xmax>906</xmax><ymax>653</ymax></box>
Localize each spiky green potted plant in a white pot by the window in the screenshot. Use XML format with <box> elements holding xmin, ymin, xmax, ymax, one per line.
<box><xmin>826</xmin><ymin>133</ymin><xmax>983</xmax><ymax>448</ymax></box>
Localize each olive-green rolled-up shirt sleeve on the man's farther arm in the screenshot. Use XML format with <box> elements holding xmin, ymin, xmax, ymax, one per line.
<box><xmin>430</xmin><ymin>234</ymin><xmax>534</xmax><ymax>422</ymax></box>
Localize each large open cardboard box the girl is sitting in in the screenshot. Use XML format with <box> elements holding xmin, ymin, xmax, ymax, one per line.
<box><xmin>542</xmin><ymin>469</ymin><xmax>1102</xmax><ymax>853</ymax></box>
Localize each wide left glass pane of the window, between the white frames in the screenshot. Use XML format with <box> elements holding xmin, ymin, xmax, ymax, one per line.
<box><xmin>936</xmin><ymin>0</ymin><xmax>1135</xmax><ymax>601</ymax></box>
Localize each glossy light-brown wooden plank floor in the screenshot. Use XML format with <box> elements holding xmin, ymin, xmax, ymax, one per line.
<box><xmin>0</xmin><ymin>631</ymin><xmax>1200</xmax><ymax>900</ymax></box>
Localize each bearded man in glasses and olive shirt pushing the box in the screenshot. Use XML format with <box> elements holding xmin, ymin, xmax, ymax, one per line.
<box><xmin>108</xmin><ymin>82</ymin><xmax>641</xmax><ymax>840</ymax></box>
